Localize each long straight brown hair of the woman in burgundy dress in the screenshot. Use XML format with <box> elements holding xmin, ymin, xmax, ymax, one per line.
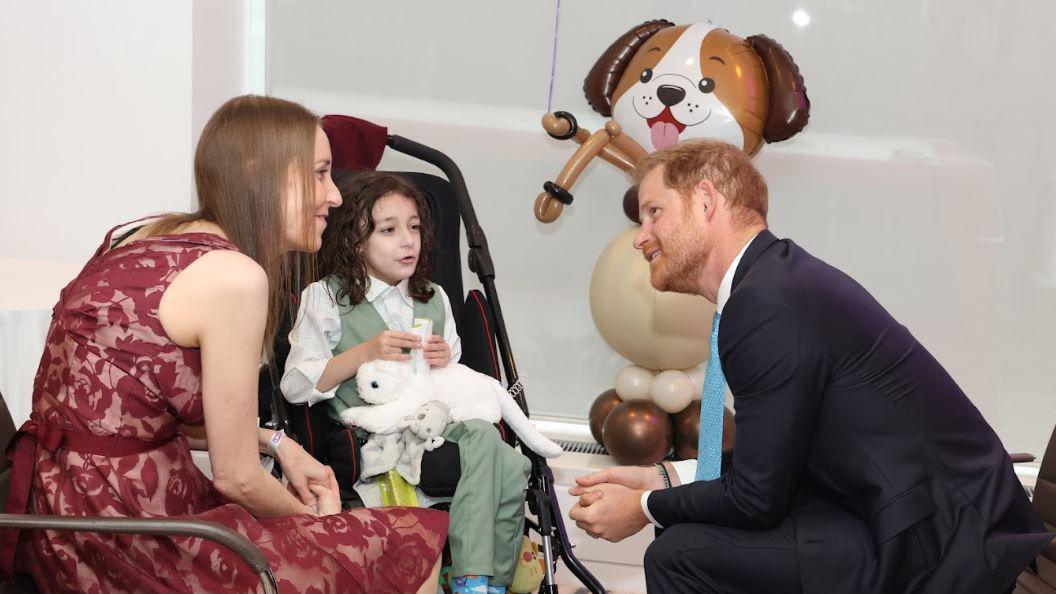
<box><xmin>149</xmin><ymin>95</ymin><xmax>319</xmax><ymax>358</ymax></box>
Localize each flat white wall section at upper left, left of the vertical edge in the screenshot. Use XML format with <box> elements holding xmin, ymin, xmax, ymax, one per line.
<box><xmin>0</xmin><ymin>0</ymin><xmax>192</xmax><ymax>261</ymax></box>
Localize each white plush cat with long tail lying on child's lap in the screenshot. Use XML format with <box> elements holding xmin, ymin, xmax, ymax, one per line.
<box><xmin>340</xmin><ymin>359</ymin><xmax>562</xmax><ymax>458</ymax></box>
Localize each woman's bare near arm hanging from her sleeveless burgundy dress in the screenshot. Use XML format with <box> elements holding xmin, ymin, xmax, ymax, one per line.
<box><xmin>158</xmin><ymin>250</ymin><xmax>318</xmax><ymax>517</ymax></box>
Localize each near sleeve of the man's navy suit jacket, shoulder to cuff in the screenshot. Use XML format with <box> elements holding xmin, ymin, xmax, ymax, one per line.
<box><xmin>648</xmin><ymin>287</ymin><xmax>830</xmax><ymax>530</ymax></box>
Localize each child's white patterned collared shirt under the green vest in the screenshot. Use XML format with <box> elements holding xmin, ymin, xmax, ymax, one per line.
<box><xmin>279</xmin><ymin>276</ymin><xmax>461</xmax><ymax>406</ymax></box>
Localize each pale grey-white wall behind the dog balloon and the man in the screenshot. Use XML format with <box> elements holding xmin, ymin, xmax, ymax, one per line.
<box><xmin>267</xmin><ymin>0</ymin><xmax>1056</xmax><ymax>452</ymax></box>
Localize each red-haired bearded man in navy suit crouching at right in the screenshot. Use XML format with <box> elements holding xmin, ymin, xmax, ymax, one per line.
<box><xmin>569</xmin><ymin>140</ymin><xmax>1053</xmax><ymax>594</ymax></box>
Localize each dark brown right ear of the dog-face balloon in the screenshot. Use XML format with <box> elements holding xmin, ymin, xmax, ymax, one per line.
<box><xmin>747</xmin><ymin>35</ymin><xmax>810</xmax><ymax>143</ymax></box>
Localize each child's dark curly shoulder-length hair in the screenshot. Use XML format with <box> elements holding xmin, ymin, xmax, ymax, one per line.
<box><xmin>318</xmin><ymin>170</ymin><xmax>434</xmax><ymax>305</ymax></box>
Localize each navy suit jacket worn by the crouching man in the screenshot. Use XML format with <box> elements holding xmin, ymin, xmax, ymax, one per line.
<box><xmin>648</xmin><ymin>230</ymin><xmax>1053</xmax><ymax>594</ymax></box>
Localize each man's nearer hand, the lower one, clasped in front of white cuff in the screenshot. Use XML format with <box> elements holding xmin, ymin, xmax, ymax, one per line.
<box><xmin>568</xmin><ymin>483</ymin><xmax>649</xmax><ymax>542</ymax></box>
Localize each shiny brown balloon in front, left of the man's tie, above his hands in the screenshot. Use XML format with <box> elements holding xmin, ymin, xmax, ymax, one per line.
<box><xmin>602</xmin><ymin>401</ymin><xmax>673</xmax><ymax>464</ymax></box>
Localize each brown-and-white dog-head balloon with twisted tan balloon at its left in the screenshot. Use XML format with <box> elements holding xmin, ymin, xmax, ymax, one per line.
<box><xmin>535</xmin><ymin>20</ymin><xmax>810</xmax><ymax>223</ymax></box>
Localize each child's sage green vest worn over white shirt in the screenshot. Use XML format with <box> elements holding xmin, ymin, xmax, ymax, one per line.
<box><xmin>326</xmin><ymin>276</ymin><xmax>444</xmax><ymax>420</ymax></box>
